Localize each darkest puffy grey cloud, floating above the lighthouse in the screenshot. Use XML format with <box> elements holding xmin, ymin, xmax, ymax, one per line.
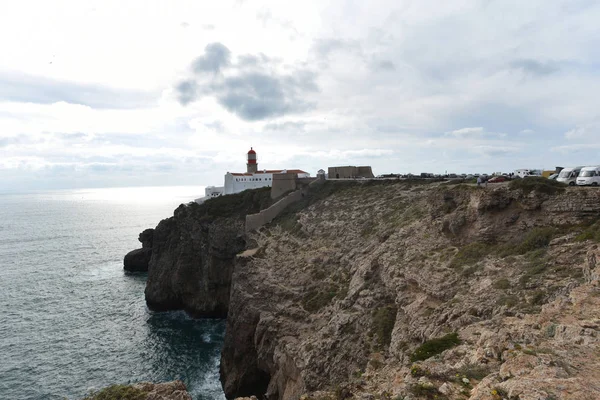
<box><xmin>175</xmin><ymin>43</ymin><xmax>319</xmax><ymax>121</ymax></box>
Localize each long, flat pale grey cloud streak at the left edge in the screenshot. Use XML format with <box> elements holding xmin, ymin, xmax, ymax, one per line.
<box><xmin>0</xmin><ymin>73</ymin><xmax>159</xmax><ymax>109</ymax></box>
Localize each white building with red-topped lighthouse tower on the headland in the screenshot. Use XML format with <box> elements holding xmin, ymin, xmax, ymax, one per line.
<box><xmin>196</xmin><ymin>148</ymin><xmax>310</xmax><ymax>203</ymax></box>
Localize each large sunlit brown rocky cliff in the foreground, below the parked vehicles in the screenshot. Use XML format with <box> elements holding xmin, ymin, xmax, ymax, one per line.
<box><xmin>218</xmin><ymin>182</ymin><xmax>600</xmax><ymax>400</ymax></box>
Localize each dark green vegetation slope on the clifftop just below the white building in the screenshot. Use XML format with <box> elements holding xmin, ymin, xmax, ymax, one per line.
<box><xmin>189</xmin><ymin>187</ymin><xmax>271</xmax><ymax>220</ymax></box>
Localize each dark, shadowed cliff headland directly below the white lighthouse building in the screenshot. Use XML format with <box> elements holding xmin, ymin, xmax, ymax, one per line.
<box><xmin>145</xmin><ymin>190</ymin><xmax>270</xmax><ymax>318</ymax></box>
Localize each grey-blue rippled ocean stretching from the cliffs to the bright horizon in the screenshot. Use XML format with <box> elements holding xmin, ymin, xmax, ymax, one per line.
<box><xmin>0</xmin><ymin>187</ymin><xmax>225</xmax><ymax>400</ymax></box>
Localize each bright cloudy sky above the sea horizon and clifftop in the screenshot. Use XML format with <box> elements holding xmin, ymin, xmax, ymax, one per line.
<box><xmin>0</xmin><ymin>0</ymin><xmax>600</xmax><ymax>191</ymax></box>
